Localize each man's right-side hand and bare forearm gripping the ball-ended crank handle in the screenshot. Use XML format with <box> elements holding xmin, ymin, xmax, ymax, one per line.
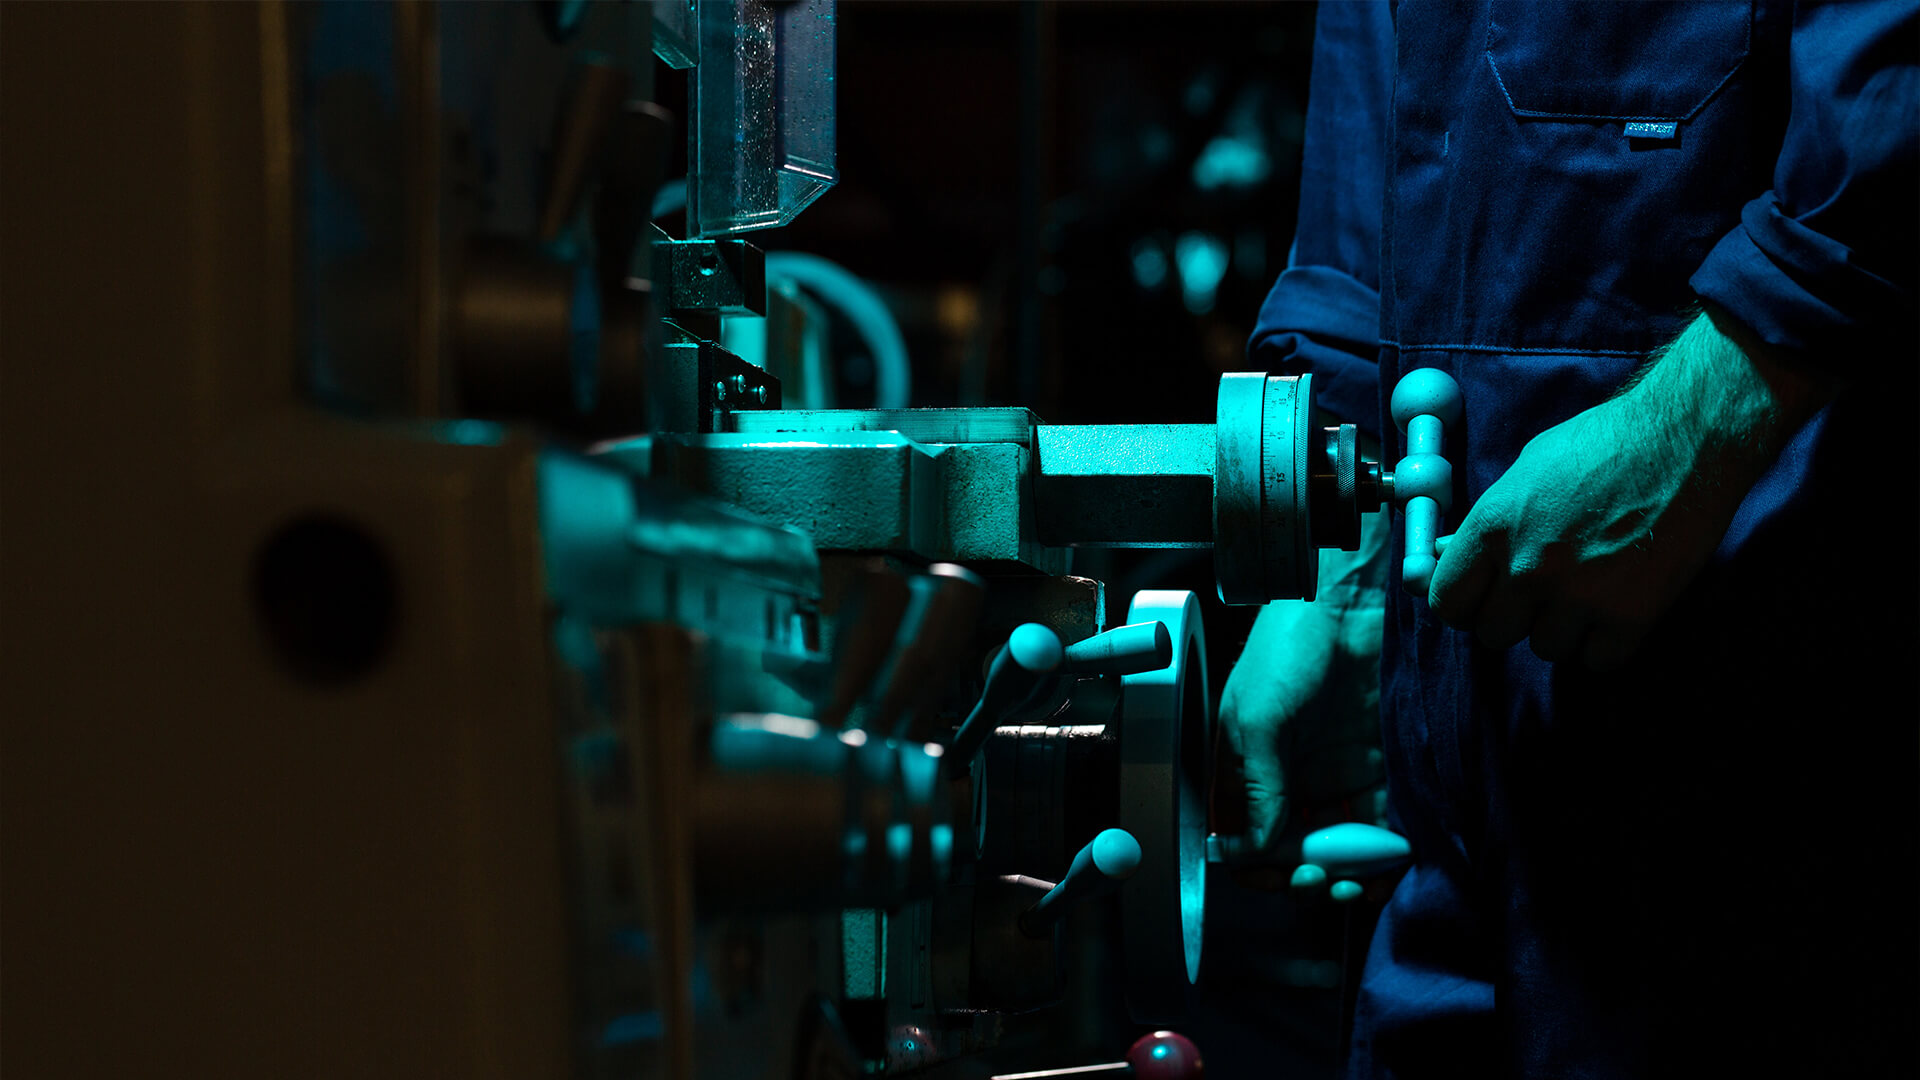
<box><xmin>1420</xmin><ymin>307</ymin><xmax>1839</xmax><ymax>671</ymax></box>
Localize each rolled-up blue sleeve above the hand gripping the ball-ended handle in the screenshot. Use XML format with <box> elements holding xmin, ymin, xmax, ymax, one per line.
<box><xmin>1692</xmin><ymin>0</ymin><xmax>1920</xmax><ymax>365</ymax></box>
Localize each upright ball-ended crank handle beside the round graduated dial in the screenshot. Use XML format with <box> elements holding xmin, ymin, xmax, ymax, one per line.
<box><xmin>1392</xmin><ymin>367</ymin><xmax>1463</xmax><ymax>598</ymax></box>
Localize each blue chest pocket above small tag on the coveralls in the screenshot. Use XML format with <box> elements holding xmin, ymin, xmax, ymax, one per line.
<box><xmin>1486</xmin><ymin>0</ymin><xmax>1753</xmax><ymax>121</ymax></box>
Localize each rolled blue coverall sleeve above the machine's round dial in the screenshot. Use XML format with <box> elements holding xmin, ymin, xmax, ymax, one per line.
<box><xmin>1246</xmin><ymin>2</ymin><xmax>1394</xmax><ymax>436</ymax></box>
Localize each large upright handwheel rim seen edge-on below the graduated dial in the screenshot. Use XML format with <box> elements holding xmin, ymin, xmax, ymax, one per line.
<box><xmin>1119</xmin><ymin>590</ymin><xmax>1213</xmax><ymax>1024</ymax></box>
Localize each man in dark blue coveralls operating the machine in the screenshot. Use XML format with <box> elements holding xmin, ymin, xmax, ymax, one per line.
<box><xmin>1221</xmin><ymin>0</ymin><xmax>1920</xmax><ymax>1076</ymax></box>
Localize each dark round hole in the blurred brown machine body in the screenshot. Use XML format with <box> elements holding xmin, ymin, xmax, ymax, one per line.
<box><xmin>253</xmin><ymin>515</ymin><xmax>399</xmax><ymax>684</ymax></box>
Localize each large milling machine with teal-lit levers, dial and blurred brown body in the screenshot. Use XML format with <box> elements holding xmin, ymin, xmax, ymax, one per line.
<box><xmin>0</xmin><ymin>0</ymin><xmax>1444</xmax><ymax>1080</ymax></box>
